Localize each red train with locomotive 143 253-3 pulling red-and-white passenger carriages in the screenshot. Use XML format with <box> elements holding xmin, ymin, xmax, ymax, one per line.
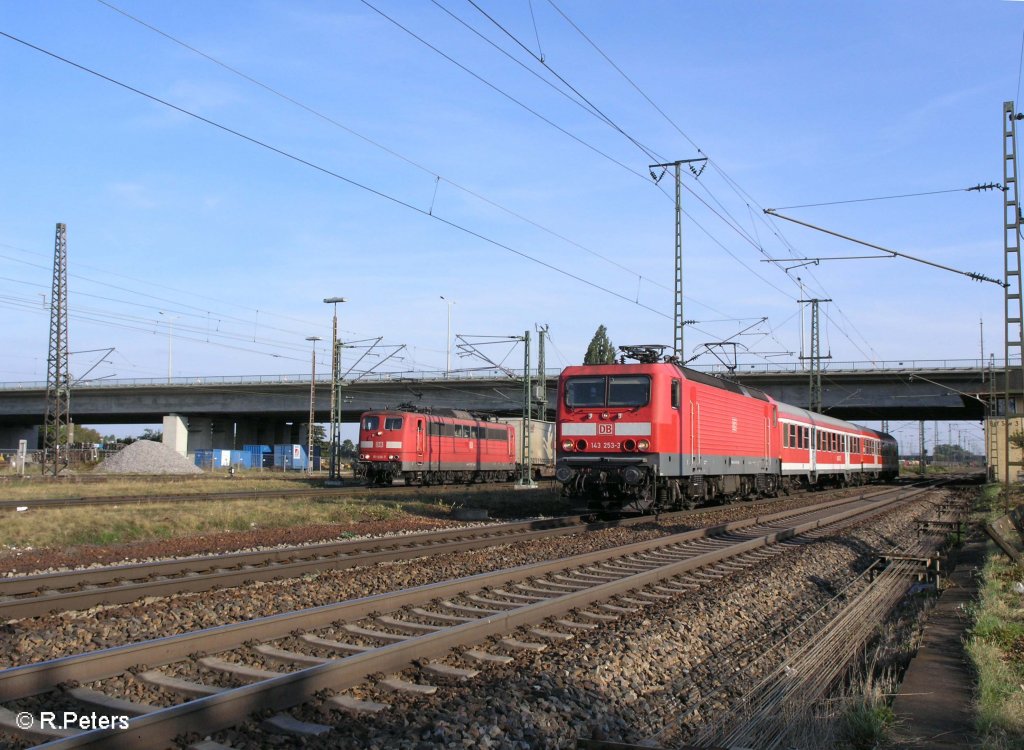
<box><xmin>555</xmin><ymin>346</ymin><xmax>899</xmax><ymax>510</ymax></box>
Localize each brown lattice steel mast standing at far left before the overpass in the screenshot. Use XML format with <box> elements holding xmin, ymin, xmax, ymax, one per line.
<box><xmin>43</xmin><ymin>223</ymin><xmax>72</xmax><ymax>476</ymax></box>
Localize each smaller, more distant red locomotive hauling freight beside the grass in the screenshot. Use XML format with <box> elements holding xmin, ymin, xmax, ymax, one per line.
<box><xmin>356</xmin><ymin>410</ymin><xmax>553</xmax><ymax>485</ymax></box>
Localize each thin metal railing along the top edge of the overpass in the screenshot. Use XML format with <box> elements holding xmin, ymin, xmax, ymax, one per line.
<box><xmin>0</xmin><ymin>359</ymin><xmax>1018</xmax><ymax>391</ymax></box>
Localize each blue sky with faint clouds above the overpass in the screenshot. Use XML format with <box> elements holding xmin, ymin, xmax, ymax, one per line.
<box><xmin>0</xmin><ymin>0</ymin><xmax>1024</xmax><ymax>450</ymax></box>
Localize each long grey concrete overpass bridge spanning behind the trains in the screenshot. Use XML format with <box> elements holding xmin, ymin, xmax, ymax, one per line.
<box><xmin>0</xmin><ymin>360</ymin><xmax>1007</xmax><ymax>451</ymax></box>
